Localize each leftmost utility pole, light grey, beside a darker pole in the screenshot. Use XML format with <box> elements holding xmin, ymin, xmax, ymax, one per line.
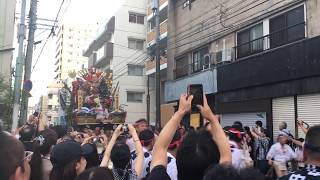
<box><xmin>11</xmin><ymin>0</ymin><xmax>26</xmax><ymax>131</ymax></box>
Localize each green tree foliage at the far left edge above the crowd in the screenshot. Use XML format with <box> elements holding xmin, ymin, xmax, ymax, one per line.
<box><xmin>0</xmin><ymin>76</ymin><xmax>13</xmax><ymax>129</ymax></box>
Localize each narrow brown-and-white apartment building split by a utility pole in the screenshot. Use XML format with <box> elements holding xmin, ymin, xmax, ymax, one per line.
<box><xmin>145</xmin><ymin>0</ymin><xmax>174</xmax><ymax>124</ymax></box>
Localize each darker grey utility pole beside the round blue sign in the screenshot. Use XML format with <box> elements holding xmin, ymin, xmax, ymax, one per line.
<box><xmin>20</xmin><ymin>0</ymin><xmax>38</xmax><ymax>122</ymax></box>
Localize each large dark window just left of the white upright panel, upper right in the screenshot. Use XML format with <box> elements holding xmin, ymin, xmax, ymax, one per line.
<box><xmin>237</xmin><ymin>23</ymin><xmax>263</xmax><ymax>58</ymax></box>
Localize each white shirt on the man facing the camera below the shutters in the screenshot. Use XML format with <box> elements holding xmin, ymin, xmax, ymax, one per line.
<box><xmin>267</xmin><ymin>143</ymin><xmax>295</xmax><ymax>163</ymax></box>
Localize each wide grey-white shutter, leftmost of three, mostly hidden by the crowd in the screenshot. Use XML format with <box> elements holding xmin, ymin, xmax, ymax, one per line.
<box><xmin>220</xmin><ymin>112</ymin><xmax>266</xmax><ymax>127</ymax></box>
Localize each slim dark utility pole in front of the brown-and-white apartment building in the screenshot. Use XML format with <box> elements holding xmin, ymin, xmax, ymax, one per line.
<box><xmin>152</xmin><ymin>0</ymin><xmax>161</xmax><ymax>128</ymax></box>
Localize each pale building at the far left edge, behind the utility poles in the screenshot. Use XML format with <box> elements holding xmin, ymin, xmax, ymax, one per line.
<box><xmin>0</xmin><ymin>0</ymin><xmax>16</xmax><ymax>81</ymax></box>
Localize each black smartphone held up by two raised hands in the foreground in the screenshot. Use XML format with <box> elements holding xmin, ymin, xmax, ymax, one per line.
<box><xmin>188</xmin><ymin>84</ymin><xmax>203</xmax><ymax>112</ymax></box>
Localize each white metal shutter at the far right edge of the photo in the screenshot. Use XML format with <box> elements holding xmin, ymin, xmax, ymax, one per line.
<box><xmin>297</xmin><ymin>94</ymin><xmax>320</xmax><ymax>138</ymax></box>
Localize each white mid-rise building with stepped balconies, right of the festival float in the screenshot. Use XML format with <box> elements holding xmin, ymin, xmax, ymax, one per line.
<box><xmin>83</xmin><ymin>0</ymin><xmax>148</xmax><ymax>122</ymax></box>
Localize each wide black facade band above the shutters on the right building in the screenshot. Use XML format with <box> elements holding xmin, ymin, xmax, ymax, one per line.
<box><xmin>217</xmin><ymin>35</ymin><xmax>320</xmax><ymax>92</ymax></box>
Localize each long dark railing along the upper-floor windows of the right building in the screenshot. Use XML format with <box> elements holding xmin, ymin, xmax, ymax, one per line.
<box><xmin>174</xmin><ymin>22</ymin><xmax>305</xmax><ymax>79</ymax></box>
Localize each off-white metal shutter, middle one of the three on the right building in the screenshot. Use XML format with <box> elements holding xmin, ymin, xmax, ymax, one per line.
<box><xmin>272</xmin><ymin>97</ymin><xmax>295</xmax><ymax>141</ymax></box>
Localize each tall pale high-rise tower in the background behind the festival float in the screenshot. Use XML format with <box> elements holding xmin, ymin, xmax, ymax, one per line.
<box><xmin>55</xmin><ymin>24</ymin><xmax>94</xmax><ymax>83</ymax></box>
